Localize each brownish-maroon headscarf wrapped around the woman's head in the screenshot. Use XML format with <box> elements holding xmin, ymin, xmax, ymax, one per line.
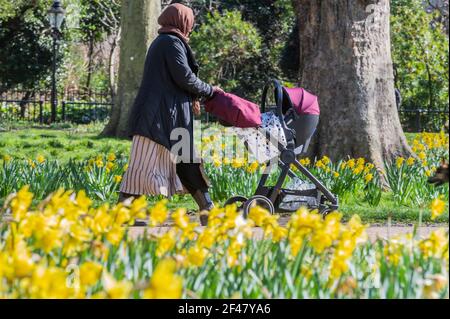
<box><xmin>158</xmin><ymin>3</ymin><xmax>195</xmax><ymax>42</ymax></box>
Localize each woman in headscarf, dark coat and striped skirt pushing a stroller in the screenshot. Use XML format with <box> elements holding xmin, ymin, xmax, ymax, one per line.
<box><xmin>119</xmin><ymin>3</ymin><xmax>221</xmax><ymax>224</ymax></box>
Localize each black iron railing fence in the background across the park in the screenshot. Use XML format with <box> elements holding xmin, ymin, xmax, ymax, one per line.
<box><xmin>0</xmin><ymin>90</ymin><xmax>449</xmax><ymax>133</ymax></box>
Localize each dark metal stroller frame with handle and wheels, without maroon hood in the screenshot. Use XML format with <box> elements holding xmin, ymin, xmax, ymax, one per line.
<box><xmin>225</xmin><ymin>79</ymin><xmax>339</xmax><ymax>217</ymax></box>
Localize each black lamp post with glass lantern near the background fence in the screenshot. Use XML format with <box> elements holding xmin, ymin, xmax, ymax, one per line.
<box><xmin>47</xmin><ymin>0</ymin><xmax>65</xmax><ymax>122</ymax></box>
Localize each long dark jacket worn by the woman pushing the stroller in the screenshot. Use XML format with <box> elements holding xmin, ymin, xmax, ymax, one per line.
<box><xmin>129</xmin><ymin>34</ymin><xmax>213</xmax><ymax>156</ymax></box>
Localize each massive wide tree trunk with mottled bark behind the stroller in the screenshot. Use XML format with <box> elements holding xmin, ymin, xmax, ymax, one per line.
<box><xmin>294</xmin><ymin>0</ymin><xmax>411</xmax><ymax>168</ymax></box>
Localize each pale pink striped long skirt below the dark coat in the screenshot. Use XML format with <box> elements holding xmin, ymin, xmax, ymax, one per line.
<box><xmin>120</xmin><ymin>135</ymin><xmax>186</xmax><ymax>197</ymax></box>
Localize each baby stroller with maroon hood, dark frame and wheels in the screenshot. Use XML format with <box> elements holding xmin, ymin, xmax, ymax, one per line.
<box><xmin>225</xmin><ymin>80</ymin><xmax>338</xmax><ymax>217</ymax></box>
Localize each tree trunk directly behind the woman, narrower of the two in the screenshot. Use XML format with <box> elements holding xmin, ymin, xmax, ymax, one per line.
<box><xmin>102</xmin><ymin>0</ymin><xmax>161</xmax><ymax>137</ymax></box>
